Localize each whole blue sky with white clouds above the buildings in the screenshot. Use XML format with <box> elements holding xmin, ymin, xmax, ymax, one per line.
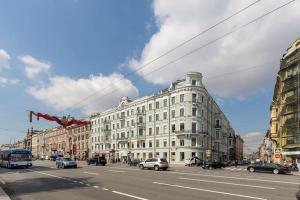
<box><xmin>0</xmin><ymin>0</ymin><xmax>300</xmax><ymax>152</ymax></box>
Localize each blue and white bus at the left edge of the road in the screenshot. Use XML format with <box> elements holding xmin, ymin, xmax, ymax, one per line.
<box><xmin>0</xmin><ymin>149</ymin><xmax>32</xmax><ymax>168</ymax></box>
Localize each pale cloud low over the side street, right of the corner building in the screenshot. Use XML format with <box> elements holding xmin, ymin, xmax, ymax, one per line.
<box><xmin>241</xmin><ymin>132</ymin><xmax>266</xmax><ymax>153</ymax></box>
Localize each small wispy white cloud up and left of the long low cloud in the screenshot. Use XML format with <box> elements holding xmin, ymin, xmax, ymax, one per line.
<box><xmin>18</xmin><ymin>55</ymin><xmax>51</xmax><ymax>79</ymax></box>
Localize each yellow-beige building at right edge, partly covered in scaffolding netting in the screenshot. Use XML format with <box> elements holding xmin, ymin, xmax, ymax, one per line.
<box><xmin>270</xmin><ymin>38</ymin><xmax>300</xmax><ymax>163</ymax></box>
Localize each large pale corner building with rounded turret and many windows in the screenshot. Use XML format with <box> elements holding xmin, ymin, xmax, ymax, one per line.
<box><xmin>90</xmin><ymin>72</ymin><xmax>234</xmax><ymax>163</ymax></box>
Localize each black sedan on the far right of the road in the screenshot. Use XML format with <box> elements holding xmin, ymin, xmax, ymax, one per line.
<box><xmin>247</xmin><ymin>163</ymin><xmax>291</xmax><ymax>174</ymax></box>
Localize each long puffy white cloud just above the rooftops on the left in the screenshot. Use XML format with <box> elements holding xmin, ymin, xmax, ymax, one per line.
<box><xmin>27</xmin><ymin>73</ymin><xmax>138</xmax><ymax>114</ymax></box>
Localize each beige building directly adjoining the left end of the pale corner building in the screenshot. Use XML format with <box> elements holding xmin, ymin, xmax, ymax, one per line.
<box><xmin>67</xmin><ymin>124</ymin><xmax>91</xmax><ymax>160</ymax></box>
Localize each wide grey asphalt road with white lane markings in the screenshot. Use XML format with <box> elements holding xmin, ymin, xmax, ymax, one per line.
<box><xmin>0</xmin><ymin>161</ymin><xmax>300</xmax><ymax>200</ymax></box>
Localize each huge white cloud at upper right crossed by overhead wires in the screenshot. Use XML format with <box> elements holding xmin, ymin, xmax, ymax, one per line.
<box><xmin>128</xmin><ymin>0</ymin><xmax>300</xmax><ymax>100</ymax></box>
